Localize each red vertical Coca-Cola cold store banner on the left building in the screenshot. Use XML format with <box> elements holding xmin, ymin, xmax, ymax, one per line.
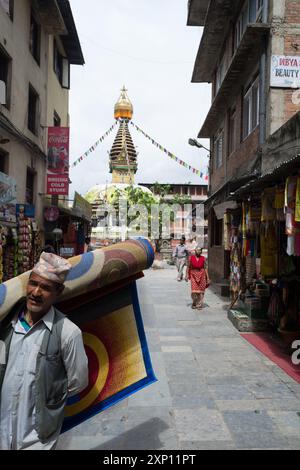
<box><xmin>47</xmin><ymin>127</ymin><xmax>70</xmax><ymax>196</ymax></box>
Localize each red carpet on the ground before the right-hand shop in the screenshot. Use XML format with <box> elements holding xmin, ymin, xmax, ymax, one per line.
<box><xmin>241</xmin><ymin>333</ymin><xmax>300</xmax><ymax>383</ymax></box>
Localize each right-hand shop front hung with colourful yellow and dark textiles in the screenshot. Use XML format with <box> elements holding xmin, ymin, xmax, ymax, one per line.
<box><xmin>224</xmin><ymin>156</ymin><xmax>300</xmax><ymax>345</ymax></box>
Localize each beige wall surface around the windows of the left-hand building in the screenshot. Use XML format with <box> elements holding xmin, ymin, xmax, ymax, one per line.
<box><xmin>0</xmin><ymin>0</ymin><xmax>69</xmax><ymax>228</ymax></box>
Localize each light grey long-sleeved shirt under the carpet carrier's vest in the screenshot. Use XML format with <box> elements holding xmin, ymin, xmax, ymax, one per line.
<box><xmin>0</xmin><ymin>307</ymin><xmax>88</xmax><ymax>450</ymax></box>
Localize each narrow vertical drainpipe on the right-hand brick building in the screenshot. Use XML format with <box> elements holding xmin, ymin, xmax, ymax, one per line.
<box><xmin>259</xmin><ymin>0</ymin><xmax>269</xmax><ymax>147</ymax></box>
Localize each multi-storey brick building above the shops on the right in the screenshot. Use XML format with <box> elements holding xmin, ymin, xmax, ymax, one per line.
<box><xmin>188</xmin><ymin>0</ymin><xmax>300</xmax><ymax>283</ymax></box>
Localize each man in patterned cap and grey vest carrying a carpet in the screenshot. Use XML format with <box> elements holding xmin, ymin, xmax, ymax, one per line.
<box><xmin>0</xmin><ymin>253</ymin><xmax>88</xmax><ymax>450</ymax></box>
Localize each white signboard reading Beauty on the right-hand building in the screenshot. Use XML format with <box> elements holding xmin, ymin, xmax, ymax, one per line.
<box><xmin>271</xmin><ymin>55</ymin><xmax>300</xmax><ymax>88</ymax></box>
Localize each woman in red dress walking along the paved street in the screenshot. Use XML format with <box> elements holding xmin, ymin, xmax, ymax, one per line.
<box><xmin>186</xmin><ymin>246</ymin><xmax>210</xmax><ymax>310</ymax></box>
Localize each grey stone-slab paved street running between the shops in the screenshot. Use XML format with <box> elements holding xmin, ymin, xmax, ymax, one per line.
<box><xmin>58</xmin><ymin>269</ymin><xmax>300</xmax><ymax>450</ymax></box>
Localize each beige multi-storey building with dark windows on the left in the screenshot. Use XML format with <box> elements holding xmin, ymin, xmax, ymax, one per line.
<box><xmin>0</xmin><ymin>0</ymin><xmax>84</xmax><ymax>229</ymax></box>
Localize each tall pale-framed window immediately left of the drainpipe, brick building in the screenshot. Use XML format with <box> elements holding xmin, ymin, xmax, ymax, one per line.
<box><xmin>243</xmin><ymin>78</ymin><xmax>259</xmax><ymax>139</ymax></box>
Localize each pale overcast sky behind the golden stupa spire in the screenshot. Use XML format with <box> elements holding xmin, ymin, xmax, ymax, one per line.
<box><xmin>70</xmin><ymin>0</ymin><xmax>211</xmax><ymax>195</ymax></box>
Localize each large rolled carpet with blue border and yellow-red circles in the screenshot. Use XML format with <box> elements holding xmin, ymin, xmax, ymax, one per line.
<box><xmin>0</xmin><ymin>239</ymin><xmax>156</xmax><ymax>432</ymax></box>
